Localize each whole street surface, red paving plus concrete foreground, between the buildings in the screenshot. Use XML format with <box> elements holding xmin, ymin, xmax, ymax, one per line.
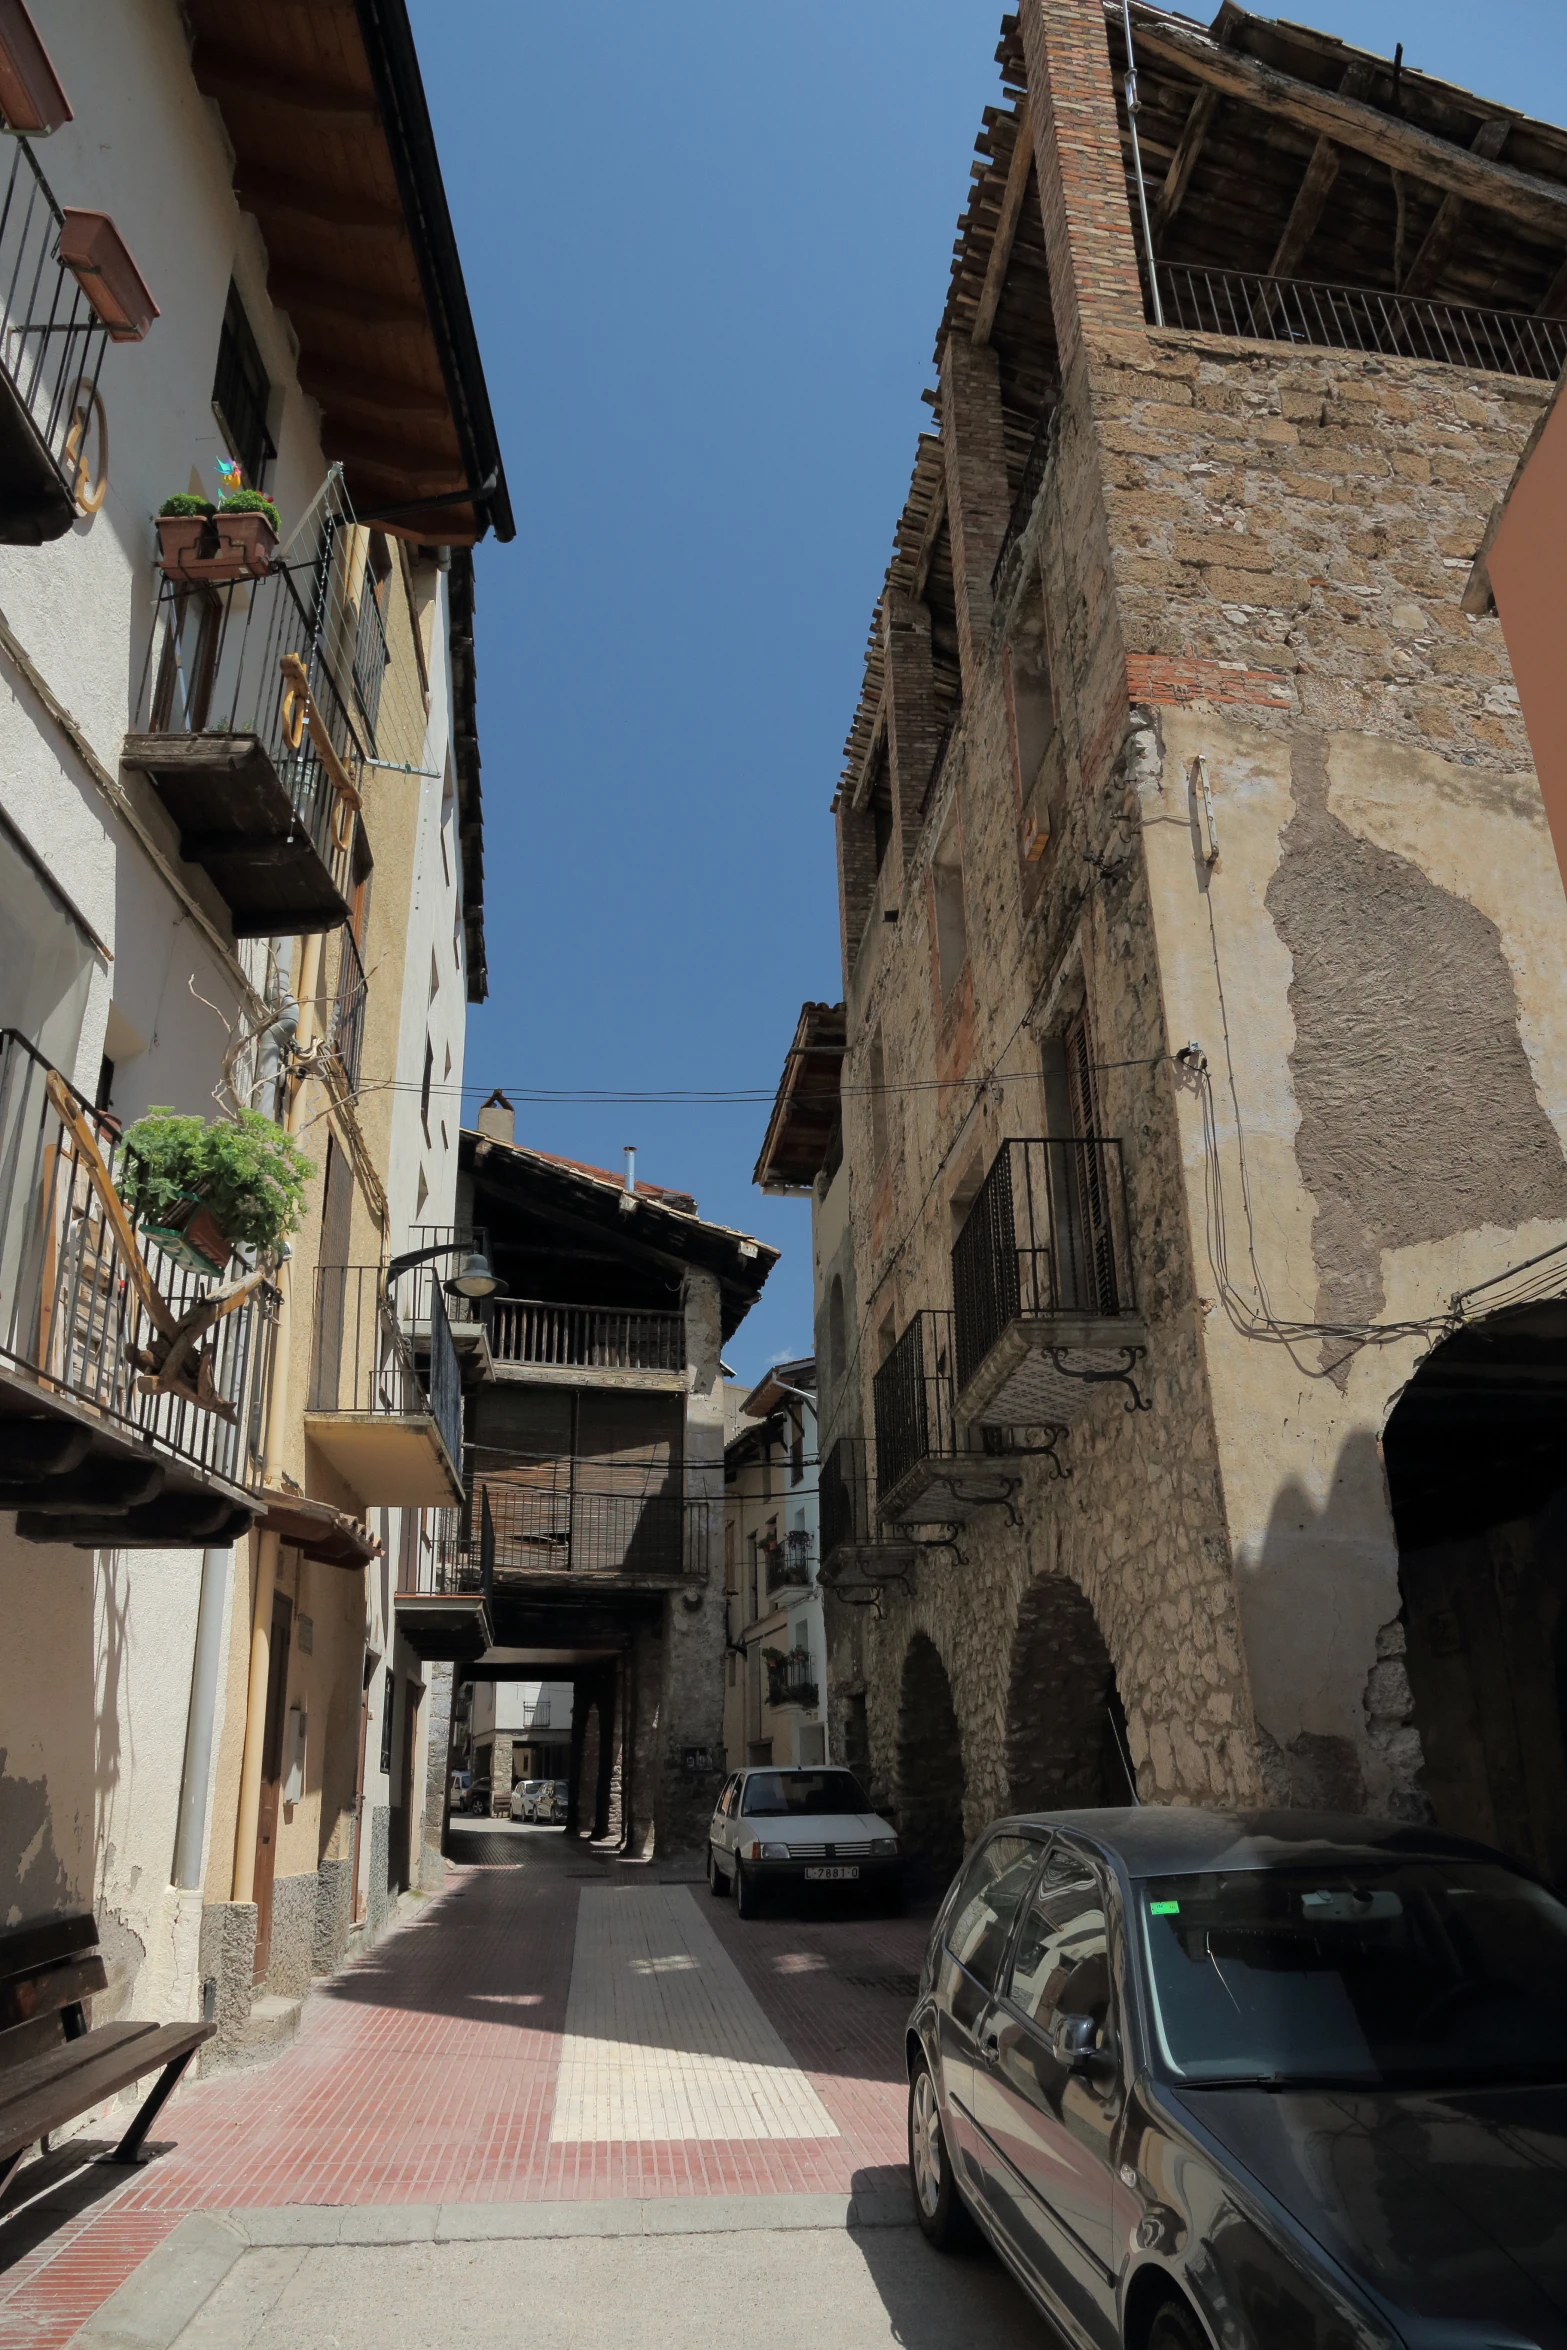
<box><xmin>0</xmin><ymin>1824</ymin><xmax>1038</xmax><ymax>2350</ymax></box>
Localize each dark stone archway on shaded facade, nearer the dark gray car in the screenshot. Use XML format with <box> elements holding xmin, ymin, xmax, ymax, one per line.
<box><xmin>1006</xmin><ymin>1575</ymin><xmax>1137</xmax><ymax>1812</ymax></box>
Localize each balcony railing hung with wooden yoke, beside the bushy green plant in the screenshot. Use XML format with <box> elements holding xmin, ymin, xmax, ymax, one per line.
<box><xmin>0</xmin><ymin>1029</ymin><xmax>277</xmax><ymax>1488</ymax></box>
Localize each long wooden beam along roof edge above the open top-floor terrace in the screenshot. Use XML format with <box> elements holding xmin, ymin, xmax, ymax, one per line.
<box><xmin>1137</xmin><ymin>12</ymin><xmax>1567</xmax><ymax>237</ymax></box>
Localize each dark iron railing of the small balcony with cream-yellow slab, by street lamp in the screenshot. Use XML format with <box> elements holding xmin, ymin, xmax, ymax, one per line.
<box><xmin>308</xmin><ymin>1264</ymin><xmax>463</xmax><ymax>1473</ymax></box>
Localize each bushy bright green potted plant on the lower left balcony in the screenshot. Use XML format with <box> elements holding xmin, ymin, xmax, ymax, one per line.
<box><xmin>120</xmin><ymin>1109</ymin><xmax>315</xmax><ymax>1274</ymax></box>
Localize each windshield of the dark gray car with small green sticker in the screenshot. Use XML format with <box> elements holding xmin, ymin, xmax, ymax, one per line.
<box><xmin>1137</xmin><ymin>1859</ymin><xmax>1567</xmax><ymax>2084</ymax></box>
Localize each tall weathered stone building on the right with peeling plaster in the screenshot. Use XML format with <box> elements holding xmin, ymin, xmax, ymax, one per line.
<box><xmin>759</xmin><ymin>0</ymin><xmax>1567</xmax><ymax>1875</ymax></box>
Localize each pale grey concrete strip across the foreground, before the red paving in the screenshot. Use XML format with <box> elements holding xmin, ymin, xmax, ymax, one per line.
<box><xmin>78</xmin><ymin>2195</ymin><xmax>1041</xmax><ymax>2350</ymax></box>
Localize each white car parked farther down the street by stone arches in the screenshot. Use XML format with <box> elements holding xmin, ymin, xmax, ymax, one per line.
<box><xmin>707</xmin><ymin>1763</ymin><xmax>902</xmax><ymax>1918</ymax></box>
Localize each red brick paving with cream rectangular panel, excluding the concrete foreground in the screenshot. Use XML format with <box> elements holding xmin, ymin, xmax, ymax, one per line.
<box><xmin>0</xmin><ymin>1831</ymin><xmax>1043</xmax><ymax>2350</ymax></box>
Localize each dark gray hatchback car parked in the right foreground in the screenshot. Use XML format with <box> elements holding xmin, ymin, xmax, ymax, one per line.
<box><xmin>907</xmin><ymin>1807</ymin><xmax>1567</xmax><ymax>2350</ymax></box>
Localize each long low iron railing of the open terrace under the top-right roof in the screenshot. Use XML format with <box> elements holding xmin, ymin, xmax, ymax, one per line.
<box><xmin>1144</xmin><ymin>261</ymin><xmax>1567</xmax><ymax>383</ymax></box>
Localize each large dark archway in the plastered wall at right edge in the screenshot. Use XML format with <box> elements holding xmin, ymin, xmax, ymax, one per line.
<box><xmin>1384</xmin><ymin>1300</ymin><xmax>1567</xmax><ymax>1885</ymax></box>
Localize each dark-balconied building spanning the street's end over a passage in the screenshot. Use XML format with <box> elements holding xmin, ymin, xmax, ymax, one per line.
<box><xmin>395</xmin><ymin>1095</ymin><xmax>778</xmax><ymax>1857</ymax></box>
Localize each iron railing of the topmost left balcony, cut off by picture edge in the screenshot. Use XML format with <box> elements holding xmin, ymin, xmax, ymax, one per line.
<box><xmin>0</xmin><ymin>139</ymin><xmax>108</xmax><ymax>524</ymax></box>
